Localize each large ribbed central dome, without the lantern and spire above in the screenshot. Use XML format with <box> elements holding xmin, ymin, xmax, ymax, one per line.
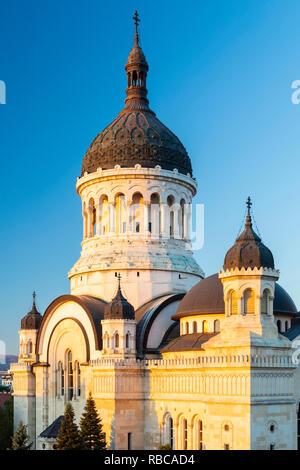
<box><xmin>81</xmin><ymin>110</ymin><xmax>192</xmax><ymax>175</ymax></box>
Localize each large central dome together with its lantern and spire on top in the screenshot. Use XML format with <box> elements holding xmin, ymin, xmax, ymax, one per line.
<box><xmin>81</xmin><ymin>18</ymin><xmax>192</xmax><ymax>176</ymax></box>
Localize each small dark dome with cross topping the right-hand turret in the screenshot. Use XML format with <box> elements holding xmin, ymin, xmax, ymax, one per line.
<box><xmin>223</xmin><ymin>197</ymin><xmax>274</xmax><ymax>270</ymax></box>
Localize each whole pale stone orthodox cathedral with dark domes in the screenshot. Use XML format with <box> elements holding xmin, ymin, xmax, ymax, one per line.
<box><xmin>11</xmin><ymin>14</ymin><xmax>300</xmax><ymax>450</ymax></box>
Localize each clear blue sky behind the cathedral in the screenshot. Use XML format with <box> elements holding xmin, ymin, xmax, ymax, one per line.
<box><xmin>0</xmin><ymin>0</ymin><xmax>300</xmax><ymax>354</ymax></box>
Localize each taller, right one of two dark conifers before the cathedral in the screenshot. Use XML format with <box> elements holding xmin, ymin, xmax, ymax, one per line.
<box><xmin>80</xmin><ymin>393</ymin><xmax>106</xmax><ymax>450</ymax></box>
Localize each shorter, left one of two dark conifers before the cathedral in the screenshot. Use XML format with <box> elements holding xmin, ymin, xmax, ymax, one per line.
<box><xmin>56</xmin><ymin>403</ymin><xmax>82</xmax><ymax>450</ymax></box>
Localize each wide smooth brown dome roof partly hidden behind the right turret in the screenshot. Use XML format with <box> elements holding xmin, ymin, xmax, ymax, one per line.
<box><xmin>172</xmin><ymin>274</ymin><xmax>297</xmax><ymax>320</ymax></box>
